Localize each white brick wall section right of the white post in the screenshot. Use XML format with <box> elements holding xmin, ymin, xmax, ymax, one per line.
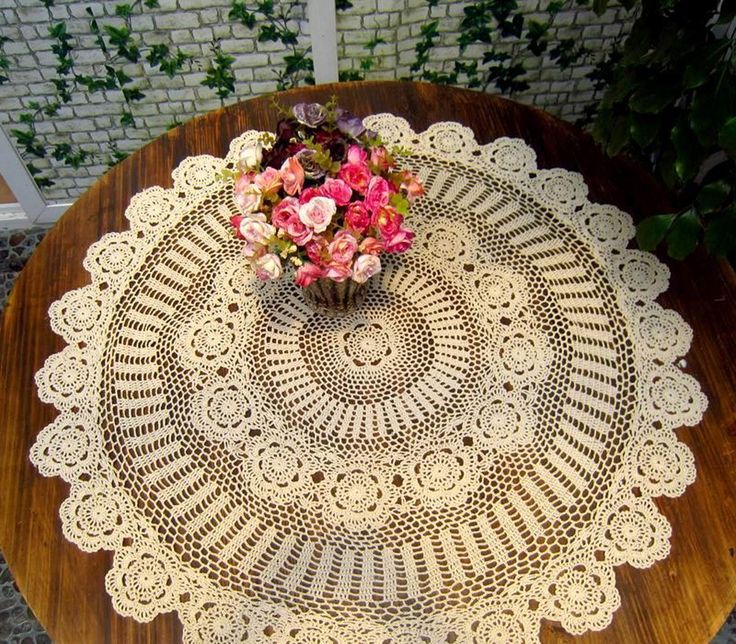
<box><xmin>337</xmin><ymin>0</ymin><xmax>631</xmax><ymax>120</ymax></box>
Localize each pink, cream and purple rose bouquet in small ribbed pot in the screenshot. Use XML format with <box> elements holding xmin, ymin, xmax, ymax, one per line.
<box><xmin>231</xmin><ymin>99</ymin><xmax>424</xmax><ymax>314</ymax></box>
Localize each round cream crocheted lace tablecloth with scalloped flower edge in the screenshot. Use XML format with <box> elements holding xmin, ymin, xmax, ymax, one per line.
<box><xmin>31</xmin><ymin>114</ymin><xmax>706</xmax><ymax>644</ymax></box>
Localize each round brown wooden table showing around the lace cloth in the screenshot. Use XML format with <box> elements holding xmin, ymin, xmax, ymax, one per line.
<box><xmin>0</xmin><ymin>82</ymin><xmax>736</xmax><ymax>644</ymax></box>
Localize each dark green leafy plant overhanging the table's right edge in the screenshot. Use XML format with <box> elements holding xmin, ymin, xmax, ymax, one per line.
<box><xmin>591</xmin><ymin>0</ymin><xmax>736</xmax><ymax>261</ymax></box>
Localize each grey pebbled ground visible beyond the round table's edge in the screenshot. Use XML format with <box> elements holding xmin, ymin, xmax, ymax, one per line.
<box><xmin>0</xmin><ymin>228</ymin><xmax>736</xmax><ymax>644</ymax></box>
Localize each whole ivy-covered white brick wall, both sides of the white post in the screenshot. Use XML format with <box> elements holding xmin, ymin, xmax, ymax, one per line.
<box><xmin>0</xmin><ymin>0</ymin><xmax>626</xmax><ymax>201</ymax></box>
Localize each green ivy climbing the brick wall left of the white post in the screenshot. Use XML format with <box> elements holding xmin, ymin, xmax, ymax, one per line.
<box><xmin>0</xmin><ymin>0</ymin><xmax>320</xmax><ymax>187</ymax></box>
